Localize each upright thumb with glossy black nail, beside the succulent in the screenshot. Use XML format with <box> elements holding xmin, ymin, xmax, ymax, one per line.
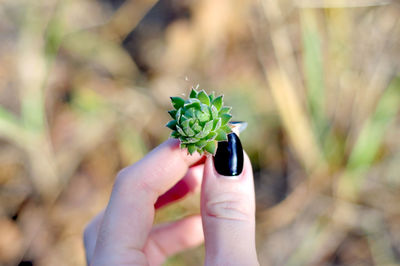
<box><xmin>201</xmin><ymin>133</ymin><xmax>258</xmax><ymax>265</ymax></box>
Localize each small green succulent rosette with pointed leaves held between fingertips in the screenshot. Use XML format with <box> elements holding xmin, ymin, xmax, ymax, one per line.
<box><xmin>166</xmin><ymin>88</ymin><xmax>232</xmax><ymax>154</ymax></box>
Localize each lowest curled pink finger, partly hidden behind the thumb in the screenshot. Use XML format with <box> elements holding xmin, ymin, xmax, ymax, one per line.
<box><xmin>144</xmin><ymin>215</ymin><xmax>204</xmax><ymax>265</ymax></box>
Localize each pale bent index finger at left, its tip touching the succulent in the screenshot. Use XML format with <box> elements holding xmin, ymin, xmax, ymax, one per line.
<box><xmin>91</xmin><ymin>139</ymin><xmax>201</xmax><ymax>264</ymax></box>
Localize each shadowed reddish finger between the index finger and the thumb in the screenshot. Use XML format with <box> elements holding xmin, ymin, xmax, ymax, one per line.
<box><xmin>154</xmin><ymin>164</ymin><xmax>204</xmax><ymax>209</ymax></box>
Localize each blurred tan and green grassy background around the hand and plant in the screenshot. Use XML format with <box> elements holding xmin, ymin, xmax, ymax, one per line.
<box><xmin>0</xmin><ymin>0</ymin><xmax>400</xmax><ymax>266</ymax></box>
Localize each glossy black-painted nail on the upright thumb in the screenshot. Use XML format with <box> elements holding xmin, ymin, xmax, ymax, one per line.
<box><xmin>214</xmin><ymin>133</ymin><xmax>243</xmax><ymax>176</ymax></box>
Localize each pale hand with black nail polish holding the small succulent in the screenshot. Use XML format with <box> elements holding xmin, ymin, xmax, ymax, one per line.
<box><xmin>84</xmin><ymin>133</ymin><xmax>258</xmax><ymax>265</ymax></box>
